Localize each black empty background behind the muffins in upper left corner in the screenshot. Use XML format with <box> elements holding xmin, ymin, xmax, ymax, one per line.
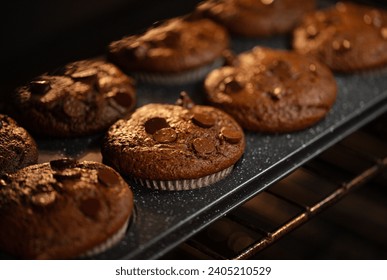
<box><xmin>0</xmin><ymin>0</ymin><xmax>200</xmax><ymax>109</ymax></box>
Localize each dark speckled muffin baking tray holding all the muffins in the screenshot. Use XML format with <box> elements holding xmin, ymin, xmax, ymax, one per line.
<box><xmin>2</xmin><ymin>1</ymin><xmax>387</xmax><ymax>259</ymax></box>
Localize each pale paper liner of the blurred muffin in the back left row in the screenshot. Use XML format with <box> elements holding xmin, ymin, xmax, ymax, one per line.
<box><xmin>131</xmin><ymin>57</ymin><xmax>224</xmax><ymax>86</ymax></box>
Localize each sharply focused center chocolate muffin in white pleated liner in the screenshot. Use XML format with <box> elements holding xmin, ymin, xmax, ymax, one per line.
<box><xmin>102</xmin><ymin>95</ymin><xmax>245</xmax><ymax>191</ymax></box>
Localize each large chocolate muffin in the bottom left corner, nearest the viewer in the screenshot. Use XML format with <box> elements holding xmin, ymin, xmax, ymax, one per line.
<box><xmin>0</xmin><ymin>159</ymin><xmax>133</xmax><ymax>259</ymax></box>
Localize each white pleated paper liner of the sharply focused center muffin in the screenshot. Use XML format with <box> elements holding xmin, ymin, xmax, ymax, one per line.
<box><xmin>133</xmin><ymin>165</ymin><xmax>234</xmax><ymax>191</ymax></box>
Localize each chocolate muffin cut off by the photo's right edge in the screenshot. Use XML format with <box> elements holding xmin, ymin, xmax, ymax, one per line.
<box><xmin>293</xmin><ymin>2</ymin><xmax>387</xmax><ymax>72</ymax></box>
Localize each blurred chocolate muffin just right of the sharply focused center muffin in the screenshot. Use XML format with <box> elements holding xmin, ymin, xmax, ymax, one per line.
<box><xmin>204</xmin><ymin>47</ymin><xmax>337</xmax><ymax>133</ymax></box>
